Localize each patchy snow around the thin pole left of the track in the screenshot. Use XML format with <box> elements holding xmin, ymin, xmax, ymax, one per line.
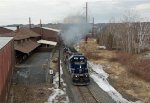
<box><xmin>46</xmin><ymin>61</ymin><xmax>69</xmax><ymax>103</ymax></box>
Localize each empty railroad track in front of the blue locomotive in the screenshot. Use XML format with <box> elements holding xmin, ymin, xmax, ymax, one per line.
<box><xmin>77</xmin><ymin>86</ymin><xmax>100</xmax><ymax>103</ymax></box>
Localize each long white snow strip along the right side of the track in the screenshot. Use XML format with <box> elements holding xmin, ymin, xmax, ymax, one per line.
<box><xmin>88</xmin><ymin>62</ymin><xmax>143</xmax><ymax>103</ymax></box>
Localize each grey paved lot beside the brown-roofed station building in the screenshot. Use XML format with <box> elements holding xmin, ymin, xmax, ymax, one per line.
<box><xmin>14</xmin><ymin>52</ymin><xmax>50</xmax><ymax>84</ymax></box>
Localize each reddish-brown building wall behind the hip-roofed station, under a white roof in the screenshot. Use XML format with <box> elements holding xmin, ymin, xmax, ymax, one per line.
<box><xmin>31</xmin><ymin>27</ymin><xmax>58</xmax><ymax>41</ymax></box>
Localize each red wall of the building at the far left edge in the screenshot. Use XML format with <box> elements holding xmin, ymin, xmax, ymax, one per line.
<box><xmin>0</xmin><ymin>40</ymin><xmax>15</xmax><ymax>103</ymax></box>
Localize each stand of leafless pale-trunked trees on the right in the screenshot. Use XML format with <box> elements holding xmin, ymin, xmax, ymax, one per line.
<box><xmin>98</xmin><ymin>11</ymin><xmax>150</xmax><ymax>53</ymax></box>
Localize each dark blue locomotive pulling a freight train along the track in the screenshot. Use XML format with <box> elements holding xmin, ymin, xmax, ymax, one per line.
<box><xmin>64</xmin><ymin>47</ymin><xmax>90</xmax><ymax>85</ymax></box>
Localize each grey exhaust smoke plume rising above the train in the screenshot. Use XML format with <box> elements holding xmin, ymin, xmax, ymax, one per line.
<box><xmin>61</xmin><ymin>15</ymin><xmax>92</xmax><ymax>46</ymax></box>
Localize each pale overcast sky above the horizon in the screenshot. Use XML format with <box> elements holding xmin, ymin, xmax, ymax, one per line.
<box><xmin>0</xmin><ymin>0</ymin><xmax>150</xmax><ymax>25</ymax></box>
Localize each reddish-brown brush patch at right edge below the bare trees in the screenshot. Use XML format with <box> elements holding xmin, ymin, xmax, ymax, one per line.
<box><xmin>117</xmin><ymin>52</ymin><xmax>150</xmax><ymax>80</ymax></box>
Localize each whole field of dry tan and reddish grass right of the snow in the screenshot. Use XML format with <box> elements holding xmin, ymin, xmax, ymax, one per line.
<box><xmin>80</xmin><ymin>40</ymin><xmax>150</xmax><ymax>103</ymax></box>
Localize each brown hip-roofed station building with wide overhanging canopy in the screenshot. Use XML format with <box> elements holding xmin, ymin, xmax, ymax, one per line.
<box><xmin>0</xmin><ymin>27</ymin><xmax>41</xmax><ymax>63</ymax></box>
